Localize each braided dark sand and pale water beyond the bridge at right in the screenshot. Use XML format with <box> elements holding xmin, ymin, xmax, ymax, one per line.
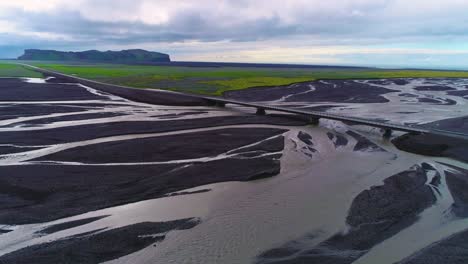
<box><xmin>224</xmin><ymin>79</ymin><xmax>468</xmax><ymax>124</ymax></box>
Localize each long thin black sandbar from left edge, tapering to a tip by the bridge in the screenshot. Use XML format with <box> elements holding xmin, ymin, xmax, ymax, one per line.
<box><xmin>0</xmin><ymin>115</ymin><xmax>306</xmax><ymax>146</ymax></box>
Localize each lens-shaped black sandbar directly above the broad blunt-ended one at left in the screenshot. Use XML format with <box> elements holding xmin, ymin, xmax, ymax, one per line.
<box><xmin>35</xmin><ymin>128</ymin><xmax>287</xmax><ymax>163</ymax></box>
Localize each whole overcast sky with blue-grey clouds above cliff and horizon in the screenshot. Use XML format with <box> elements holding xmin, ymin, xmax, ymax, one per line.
<box><xmin>0</xmin><ymin>0</ymin><xmax>468</xmax><ymax>68</ymax></box>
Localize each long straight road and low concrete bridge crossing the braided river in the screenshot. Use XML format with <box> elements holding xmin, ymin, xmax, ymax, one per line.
<box><xmin>18</xmin><ymin>63</ymin><xmax>468</xmax><ymax>140</ymax></box>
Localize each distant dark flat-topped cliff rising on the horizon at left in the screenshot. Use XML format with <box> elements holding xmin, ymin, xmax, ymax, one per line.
<box><xmin>18</xmin><ymin>49</ymin><xmax>171</xmax><ymax>63</ymax></box>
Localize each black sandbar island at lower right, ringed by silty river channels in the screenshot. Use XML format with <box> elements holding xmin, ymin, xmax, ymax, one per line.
<box><xmin>257</xmin><ymin>164</ymin><xmax>436</xmax><ymax>264</ymax></box>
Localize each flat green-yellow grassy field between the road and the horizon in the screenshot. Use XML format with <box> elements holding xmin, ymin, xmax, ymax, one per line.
<box><xmin>23</xmin><ymin>62</ymin><xmax>468</xmax><ymax>95</ymax></box>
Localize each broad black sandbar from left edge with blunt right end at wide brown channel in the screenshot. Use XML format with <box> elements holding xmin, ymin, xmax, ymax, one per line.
<box><xmin>0</xmin><ymin>150</ymin><xmax>283</xmax><ymax>224</ymax></box>
